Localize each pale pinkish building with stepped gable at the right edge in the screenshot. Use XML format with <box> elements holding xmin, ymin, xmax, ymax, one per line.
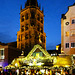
<box><xmin>61</xmin><ymin>3</ymin><xmax>75</xmax><ymax>55</ymax></box>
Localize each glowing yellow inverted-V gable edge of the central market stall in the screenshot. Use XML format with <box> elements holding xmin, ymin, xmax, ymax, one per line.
<box><xmin>27</xmin><ymin>44</ymin><xmax>51</xmax><ymax>57</ymax></box>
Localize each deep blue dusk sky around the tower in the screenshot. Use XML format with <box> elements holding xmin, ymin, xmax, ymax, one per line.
<box><xmin>0</xmin><ymin>0</ymin><xmax>75</xmax><ymax>50</ymax></box>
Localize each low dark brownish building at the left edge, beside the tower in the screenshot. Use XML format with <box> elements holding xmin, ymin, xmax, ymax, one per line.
<box><xmin>0</xmin><ymin>43</ymin><xmax>22</xmax><ymax>67</ymax></box>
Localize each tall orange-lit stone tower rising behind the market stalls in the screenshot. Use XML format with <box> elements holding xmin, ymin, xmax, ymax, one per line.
<box><xmin>17</xmin><ymin>0</ymin><xmax>46</xmax><ymax>52</ymax></box>
